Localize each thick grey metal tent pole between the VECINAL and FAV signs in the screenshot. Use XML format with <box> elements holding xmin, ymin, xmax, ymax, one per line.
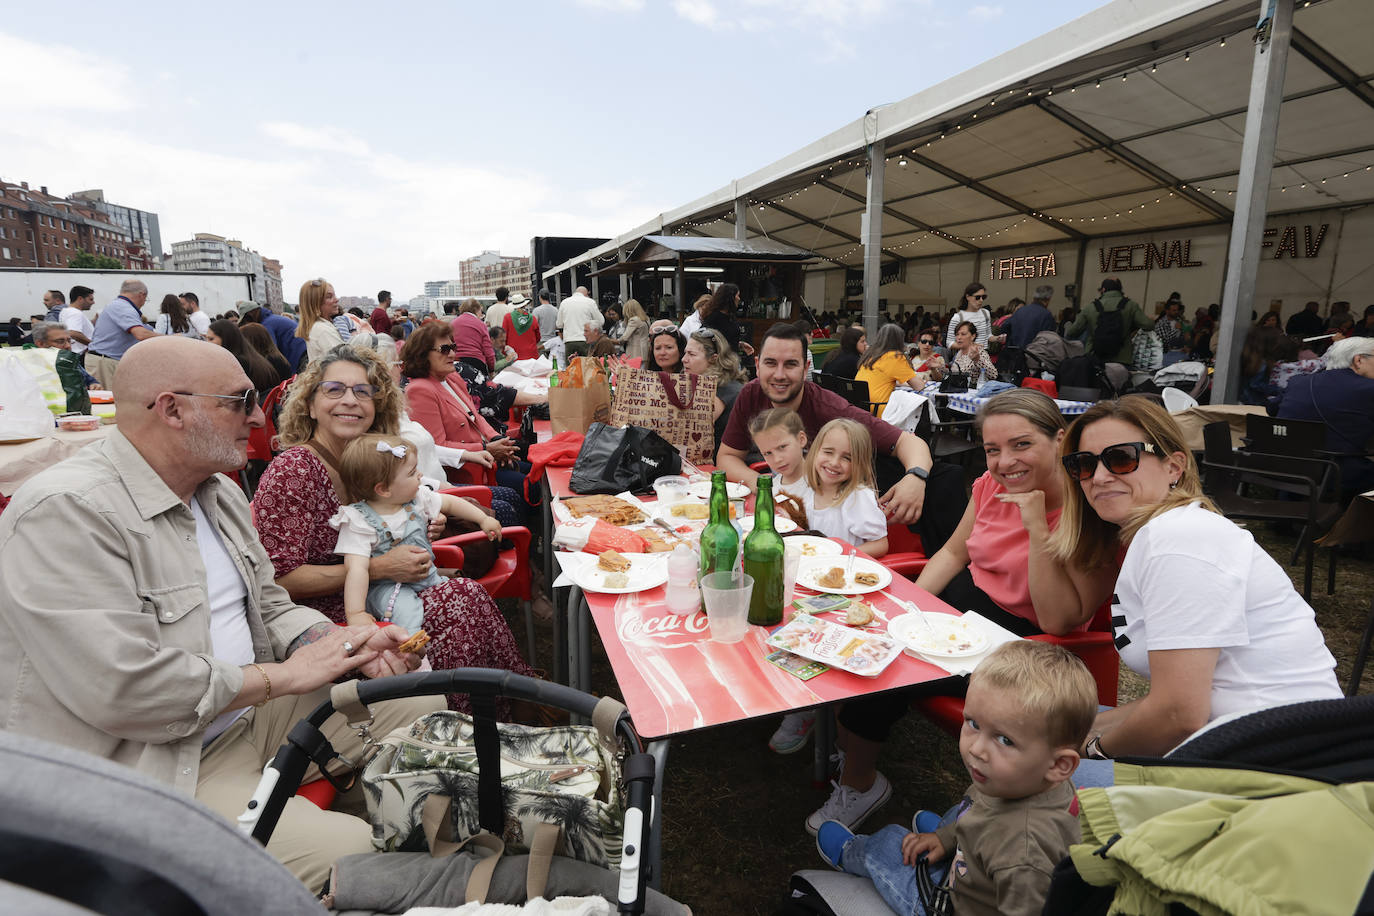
<box><xmin>1212</xmin><ymin>0</ymin><xmax>1294</xmax><ymax>404</ymax></box>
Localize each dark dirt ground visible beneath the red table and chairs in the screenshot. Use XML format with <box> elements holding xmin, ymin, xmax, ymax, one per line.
<box><xmin>519</xmin><ymin>525</ymin><xmax>1374</xmax><ymax>916</ymax></box>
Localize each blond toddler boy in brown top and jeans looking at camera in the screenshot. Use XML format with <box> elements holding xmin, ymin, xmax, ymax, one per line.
<box><xmin>816</xmin><ymin>640</ymin><xmax>1098</xmax><ymax>916</ymax></box>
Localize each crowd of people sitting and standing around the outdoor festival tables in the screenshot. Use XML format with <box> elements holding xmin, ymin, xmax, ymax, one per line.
<box><xmin>0</xmin><ymin>279</ymin><xmax>1374</xmax><ymax>913</ymax></box>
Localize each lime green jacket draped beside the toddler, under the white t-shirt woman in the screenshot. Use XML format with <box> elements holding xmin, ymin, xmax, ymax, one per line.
<box><xmin>1069</xmin><ymin>764</ymin><xmax>1374</xmax><ymax>916</ymax></box>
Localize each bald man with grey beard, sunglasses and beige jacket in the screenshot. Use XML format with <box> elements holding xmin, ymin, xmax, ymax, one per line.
<box><xmin>0</xmin><ymin>336</ymin><xmax>440</xmax><ymax>890</ymax></box>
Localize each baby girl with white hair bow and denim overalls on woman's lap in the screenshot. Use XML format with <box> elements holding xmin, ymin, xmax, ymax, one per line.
<box><xmin>330</xmin><ymin>434</ymin><xmax>502</xmax><ymax>630</ymax></box>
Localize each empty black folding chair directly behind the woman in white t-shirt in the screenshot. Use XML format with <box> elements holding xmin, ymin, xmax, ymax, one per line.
<box><xmin>1202</xmin><ymin>420</ymin><xmax>1341</xmax><ymax>600</ymax></box>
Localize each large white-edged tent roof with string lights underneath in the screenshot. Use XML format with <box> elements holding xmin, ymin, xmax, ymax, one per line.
<box><xmin>544</xmin><ymin>0</ymin><xmax>1374</xmax><ymax>277</ymax></box>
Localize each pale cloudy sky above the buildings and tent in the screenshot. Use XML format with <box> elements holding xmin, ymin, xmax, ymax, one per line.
<box><xmin>0</xmin><ymin>0</ymin><xmax>1101</xmax><ymax>301</ymax></box>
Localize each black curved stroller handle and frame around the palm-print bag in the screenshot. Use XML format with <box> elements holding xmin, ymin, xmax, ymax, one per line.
<box><xmin>239</xmin><ymin>669</ymin><xmax>671</xmax><ymax>913</ymax></box>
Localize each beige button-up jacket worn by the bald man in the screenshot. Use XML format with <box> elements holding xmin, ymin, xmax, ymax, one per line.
<box><xmin>0</xmin><ymin>430</ymin><xmax>327</xmax><ymax>794</ymax></box>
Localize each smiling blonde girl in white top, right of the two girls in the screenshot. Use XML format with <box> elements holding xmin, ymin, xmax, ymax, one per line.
<box><xmin>805</xmin><ymin>419</ymin><xmax>888</xmax><ymax>556</ymax></box>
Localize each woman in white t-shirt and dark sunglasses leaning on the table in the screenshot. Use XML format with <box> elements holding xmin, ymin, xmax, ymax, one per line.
<box><xmin>1051</xmin><ymin>397</ymin><xmax>1341</xmax><ymax>757</ymax></box>
